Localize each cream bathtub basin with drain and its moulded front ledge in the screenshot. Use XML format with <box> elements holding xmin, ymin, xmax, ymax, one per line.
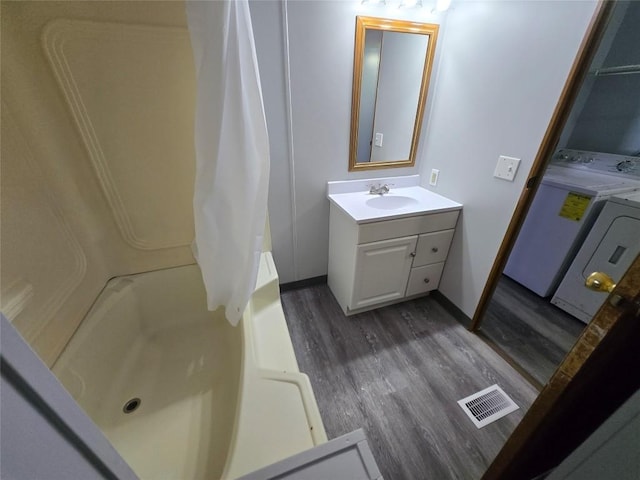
<box><xmin>53</xmin><ymin>252</ymin><xmax>326</xmax><ymax>480</ymax></box>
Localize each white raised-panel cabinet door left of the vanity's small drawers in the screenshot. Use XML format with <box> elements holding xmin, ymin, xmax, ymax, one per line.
<box><xmin>349</xmin><ymin>235</ymin><xmax>418</xmax><ymax>310</ymax></box>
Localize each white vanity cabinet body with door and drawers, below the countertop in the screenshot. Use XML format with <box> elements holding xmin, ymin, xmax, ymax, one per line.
<box><xmin>328</xmin><ymin>204</ymin><xmax>459</xmax><ymax>315</ymax></box>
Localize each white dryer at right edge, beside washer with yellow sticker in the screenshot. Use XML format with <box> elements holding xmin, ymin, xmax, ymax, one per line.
<box><xmin>551</xmin><ymin>192</ymin><xmax>640</xmax><ymax>323</ymax></box>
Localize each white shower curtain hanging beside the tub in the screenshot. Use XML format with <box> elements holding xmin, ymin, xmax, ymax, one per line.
<box><xmin>186</xmin><ymin>0</ymin><xmax>269</xmax><ymax>325</ymax></box>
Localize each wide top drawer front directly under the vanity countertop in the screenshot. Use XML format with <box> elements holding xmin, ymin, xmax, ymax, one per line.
<box><xmin>358</xmin><ymin>210</ymin><xmax>459</xmax><ymax>244</ymax></box>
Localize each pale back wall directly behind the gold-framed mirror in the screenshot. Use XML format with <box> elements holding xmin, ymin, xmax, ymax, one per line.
<box><xmin>278</xmin><ymin>0</ymin><xmax>448</xmax><ymax>282</ymax></box>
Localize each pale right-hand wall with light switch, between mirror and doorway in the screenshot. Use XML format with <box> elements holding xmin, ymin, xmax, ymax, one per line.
<box><xmin>421</xmin><ymin>1</ymin><xmax>595</xmax><ymax>316</ymax></box>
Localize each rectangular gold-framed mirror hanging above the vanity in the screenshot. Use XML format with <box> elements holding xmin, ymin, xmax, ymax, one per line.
<box><xmin>349</xmin><ymin>16</ymin><xmax>438</xmax><ymax>171</ymax></box>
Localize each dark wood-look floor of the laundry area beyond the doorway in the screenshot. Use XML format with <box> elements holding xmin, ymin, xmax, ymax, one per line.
<box><xmin>480</xmin><ymin>275</ymin><xmax>586</xmax><ymax>385</ymax></box>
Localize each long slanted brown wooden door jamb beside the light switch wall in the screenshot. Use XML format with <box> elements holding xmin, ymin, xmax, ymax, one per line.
<box><xmin>469</xmin><ymin>0</ymin><xmax>615</xmax><ymax>332</ymax></box>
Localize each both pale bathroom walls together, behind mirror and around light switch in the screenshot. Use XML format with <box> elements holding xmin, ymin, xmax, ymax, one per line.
<box><xmin>251</xmin><ymin>0</ymin><xmax>595</xmax><ymax>316</ymax></box>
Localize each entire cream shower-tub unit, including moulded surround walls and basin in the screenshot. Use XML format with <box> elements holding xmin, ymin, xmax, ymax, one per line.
<box><xmin>0</xmin><ymin>5</ymin><xmax>326</xmax><ymax>480</ymax></box>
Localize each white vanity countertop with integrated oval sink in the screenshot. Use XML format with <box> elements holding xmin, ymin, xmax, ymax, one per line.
<box><xmin>327</xmin><ymin>184</ymin><xmax>462</xmax><ymax>223</ymax></box>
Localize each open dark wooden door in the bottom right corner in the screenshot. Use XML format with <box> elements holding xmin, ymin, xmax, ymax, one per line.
<box><xmin>482</xmin><ymin>255</ymin><xmax>640</xmax><ymax>480</ymax></box>
